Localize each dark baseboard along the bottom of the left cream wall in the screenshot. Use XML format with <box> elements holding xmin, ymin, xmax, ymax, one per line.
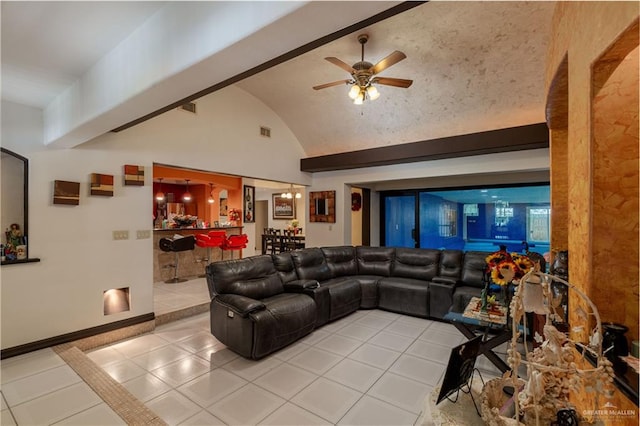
<box><xmin>0</xmin><ymin>312</ymin><xmax>156</xmax><ymax>359</ymax></box>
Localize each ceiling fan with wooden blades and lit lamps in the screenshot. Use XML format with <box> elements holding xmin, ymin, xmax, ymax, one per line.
<box><xmin>313</xmin><ymin>34</ymin><xmax>413</xmax><ymax>105</ymax></box>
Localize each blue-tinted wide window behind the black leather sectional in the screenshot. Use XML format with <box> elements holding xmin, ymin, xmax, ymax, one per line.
<box><xmin>383</xmin><ymin>185</ymin><xmax>551</xmax><ymax>253</ymax></box>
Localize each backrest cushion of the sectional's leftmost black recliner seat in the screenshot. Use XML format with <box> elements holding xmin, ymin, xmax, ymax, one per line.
<box><xmin>207</xmin><ymin>255</ymin><xmax>284</xmax><ymax>300</ymax></box>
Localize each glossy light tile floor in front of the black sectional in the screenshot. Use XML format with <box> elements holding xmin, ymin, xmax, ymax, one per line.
<box><xmin>1</xmin><ymin>310</ymin><xmax>510</xmax><ymax>425</ymax></box>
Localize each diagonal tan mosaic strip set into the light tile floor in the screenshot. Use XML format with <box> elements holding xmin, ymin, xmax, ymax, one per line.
<box><xmin>53</xmin><ymin>343</ymin><xmax>167</xmax><ymax>426</ymax></box>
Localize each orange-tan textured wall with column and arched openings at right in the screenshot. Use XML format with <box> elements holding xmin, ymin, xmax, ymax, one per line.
<box><xmin>546</xmin><ymin>2</ymin><xmax>640</xmax><ymax>418</ymax></box>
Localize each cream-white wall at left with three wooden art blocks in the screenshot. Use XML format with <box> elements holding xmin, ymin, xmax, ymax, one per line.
<box><xmin>0</xmin><ymin>87</ymin><xmax>310</xmax><ymax>349</ymax></box>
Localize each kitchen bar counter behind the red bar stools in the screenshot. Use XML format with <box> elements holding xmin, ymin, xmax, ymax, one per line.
<box><xmin>153</xmin><ymin>226</ymin><xmax>242</xmax><ymax>282</ymax></box>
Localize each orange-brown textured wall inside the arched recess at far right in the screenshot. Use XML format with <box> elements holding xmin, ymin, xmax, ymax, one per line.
<box><xmin>590</xmin><ymin>44</ymin><xmax>640</xmax><ymax>332</ymax></box>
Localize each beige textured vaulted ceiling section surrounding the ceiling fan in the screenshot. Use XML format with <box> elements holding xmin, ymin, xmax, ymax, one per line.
<box><xmin>237</xmin><ymin>2</ymin><xmax>555</xmax><ymax>156</ymax></box>
